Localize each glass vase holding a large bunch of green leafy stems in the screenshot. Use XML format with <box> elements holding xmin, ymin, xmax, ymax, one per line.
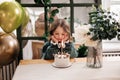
<box><xmin>87</xmin><ymin>7</ymin><xmax>120</xmax><ymax>68</ymax></box>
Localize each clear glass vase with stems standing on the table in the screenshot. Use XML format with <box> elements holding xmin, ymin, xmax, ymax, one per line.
<box><xmin>87</xmin><ymin>41</ymin><xmax>102</xmax><ymax>68</ymax></box>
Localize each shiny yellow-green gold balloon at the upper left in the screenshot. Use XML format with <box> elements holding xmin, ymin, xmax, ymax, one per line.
<box><xmin>0</xmin><ymin>1</ymin><xmax>24</xmax><ymax>33</ymax></box>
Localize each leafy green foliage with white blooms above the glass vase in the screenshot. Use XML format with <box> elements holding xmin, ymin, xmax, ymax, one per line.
<box><xmin>88</xmin><ymin>7</ymin><xmax>119</xmax><ymax>40</ymax></box>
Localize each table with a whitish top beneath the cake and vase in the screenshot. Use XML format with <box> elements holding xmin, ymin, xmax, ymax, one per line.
<box><xmin>12</xmin><ymin>58</ymin><xmax>120</xmax><ymax>80</ymax></box>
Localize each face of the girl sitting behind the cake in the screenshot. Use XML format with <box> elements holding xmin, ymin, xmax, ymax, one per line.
<box><xmin>53</xmin><ymin>26</ymin><xmax>67</xmax><ymax>42</ymax></box>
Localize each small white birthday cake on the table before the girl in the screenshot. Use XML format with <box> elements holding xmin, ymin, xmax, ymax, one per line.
<box><xmin>54</xmin><ymin>54</ymin><xmax>71</xmax><ymax>67</ymax></box>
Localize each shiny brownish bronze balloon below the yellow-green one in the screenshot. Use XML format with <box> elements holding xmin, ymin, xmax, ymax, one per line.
<box><xmin>0</xmin><ymin>33</ymin><xmax>20</xmax><ymax>66</ymax></box>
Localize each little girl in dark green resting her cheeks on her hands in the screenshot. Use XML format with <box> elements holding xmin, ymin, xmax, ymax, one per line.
<box><xmin>42</xmin><ymin>19</ymin><xmax>78</xmax><ymax>60</ymax></box>
